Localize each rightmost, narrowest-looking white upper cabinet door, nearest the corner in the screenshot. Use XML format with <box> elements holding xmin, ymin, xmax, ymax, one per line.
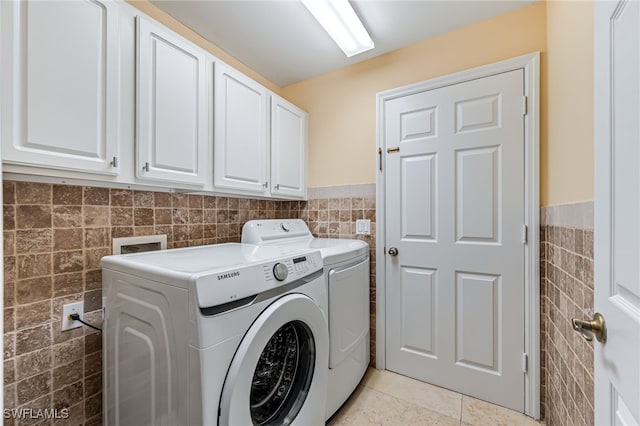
<box><xmin>271</xmin><ymin>95</ymin><xmax>307</xmax><ymax>198</ymax></box>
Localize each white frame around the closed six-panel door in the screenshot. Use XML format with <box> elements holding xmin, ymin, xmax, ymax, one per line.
<box><xmin>375</xmin><ymin>52</ymin><xmax>540</xmax><ymax>419</ymax></box>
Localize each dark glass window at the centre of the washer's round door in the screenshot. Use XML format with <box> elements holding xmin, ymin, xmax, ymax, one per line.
<box><xmin>249</xmin><ymin>321</ymin><xmax>316</xmax><ymax>426</ymax></box>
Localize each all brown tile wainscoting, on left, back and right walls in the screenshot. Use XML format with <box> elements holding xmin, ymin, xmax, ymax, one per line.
<box><xmin>3</xmin><ymin>181</ymin><xmax>594</xmax><ymax>426</ymax></box>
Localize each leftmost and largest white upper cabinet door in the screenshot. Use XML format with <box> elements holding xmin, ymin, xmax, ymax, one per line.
<box><xmin>0</xmin><ymin>0</ymin><xmax>120</xmax><ymax>175</ymax></box>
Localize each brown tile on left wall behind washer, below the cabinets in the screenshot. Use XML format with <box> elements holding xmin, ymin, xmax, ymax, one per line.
<box><xmin>3</xmin><ymin>181</ymin><xmax>302</xmax><ymax>425</ymax></box>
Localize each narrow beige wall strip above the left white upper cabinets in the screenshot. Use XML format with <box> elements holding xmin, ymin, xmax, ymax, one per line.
<box><xmin>126</xmin><ymin>0</ymin><xmax>281</xmax><ymax>94</ymax></box>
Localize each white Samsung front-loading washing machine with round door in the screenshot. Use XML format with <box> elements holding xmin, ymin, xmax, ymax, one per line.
<box><xmin>102</xmin><ymin>243</ymin><xmax>329</xmax><ymax>426</ymax></box>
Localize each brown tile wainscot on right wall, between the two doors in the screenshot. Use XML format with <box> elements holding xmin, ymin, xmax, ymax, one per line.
<box><xmin>540</xmin><ymin>203</ymin><xmax>594</xmax><ymax>426</ymax></box>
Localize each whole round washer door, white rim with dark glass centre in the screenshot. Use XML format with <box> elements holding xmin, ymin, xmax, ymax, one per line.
<box><xmin>219</xmin><ymin>294</ymin><xmax>329</xmax><ymax>426</ymax></box>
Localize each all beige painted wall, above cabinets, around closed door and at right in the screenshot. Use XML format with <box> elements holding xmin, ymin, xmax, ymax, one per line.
<box><xmin>128</xmin><ymin>0</ymin><xmax>593</xmax><ymax>205</ymax></box>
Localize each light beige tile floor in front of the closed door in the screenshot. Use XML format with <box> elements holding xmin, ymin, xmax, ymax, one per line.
<box><xmin>328</xmin><ymin>368</ymin><xmax>540</xmax><ymax>426</ymax></box>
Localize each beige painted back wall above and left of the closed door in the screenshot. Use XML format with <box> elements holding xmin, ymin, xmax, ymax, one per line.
<box><xmin>282</xmin><ymin>2</ymin><xmax>546</xmax><ymax>193</ymax></box>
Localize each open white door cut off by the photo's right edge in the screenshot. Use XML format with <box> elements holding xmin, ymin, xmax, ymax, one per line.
<box><xmin>596</xmin><ymin>1</ymin><xmax>640</xmax><ymax>426</ymax></box>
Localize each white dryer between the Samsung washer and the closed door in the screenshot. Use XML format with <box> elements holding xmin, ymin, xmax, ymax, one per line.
<box><xmin>242</xmin><ymin>219</ymin><xmax>369</xmax><ymax>419</ymax></box>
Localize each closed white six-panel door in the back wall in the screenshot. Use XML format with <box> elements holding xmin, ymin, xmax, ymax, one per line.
<box><xmin>383</xmin><ymin>70</ymin><xmax>525</xmax><ymax>411</ymax></box>
